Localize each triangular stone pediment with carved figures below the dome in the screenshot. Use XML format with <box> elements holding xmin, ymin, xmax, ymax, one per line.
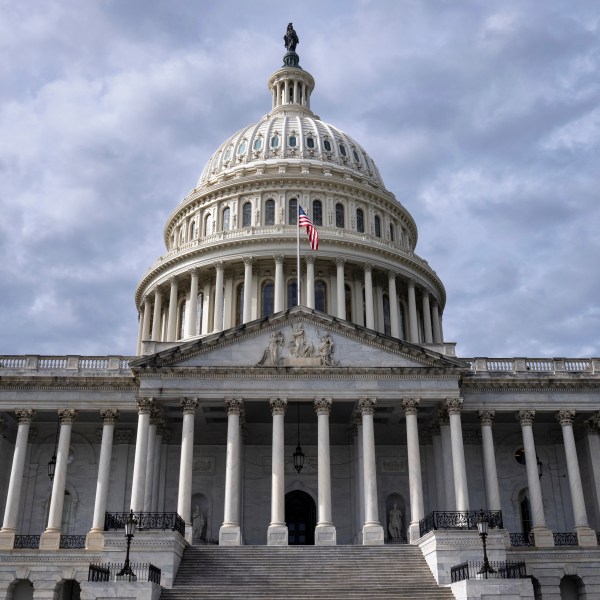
<box><xmin>131</xmin><ymin>307</ymin><xmax>468</xmax><ymax>370</ymax></box>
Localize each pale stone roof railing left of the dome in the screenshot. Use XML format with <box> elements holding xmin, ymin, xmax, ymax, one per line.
<box><xmin>0</xmin><ymin>354</ymin><xmax>136</xmax><ymax>372</ymax></box>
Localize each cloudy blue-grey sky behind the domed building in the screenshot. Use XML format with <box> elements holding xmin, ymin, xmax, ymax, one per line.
<box><xmin>0</xmin><ymin>0</ymin><xmax>600</xmax><ymax>357</ymax></box>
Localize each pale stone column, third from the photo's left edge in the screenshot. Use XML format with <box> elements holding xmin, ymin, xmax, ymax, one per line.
<box><xmin>85</xmin><ymin>409</ymin><xmax>119</xmax><ymax>551</ymax></box>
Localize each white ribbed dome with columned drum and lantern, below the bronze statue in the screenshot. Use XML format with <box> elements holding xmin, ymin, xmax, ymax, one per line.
<box><xmin>135</xmin><ymin>35</ymin><xmax>446</xmax><ymax>353</ymax></box>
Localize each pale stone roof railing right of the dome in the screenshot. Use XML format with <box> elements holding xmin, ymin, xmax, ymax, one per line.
<box><xmin>464</xmin><ymin>357</ymin><xmax>600</xmax><ymax>374</ymax></box>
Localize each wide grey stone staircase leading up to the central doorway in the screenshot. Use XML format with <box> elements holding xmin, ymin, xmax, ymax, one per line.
<box><xmin>161</xmin><ymin>545</ymin><xmax>454</xmax><ymax>600</ymax></box>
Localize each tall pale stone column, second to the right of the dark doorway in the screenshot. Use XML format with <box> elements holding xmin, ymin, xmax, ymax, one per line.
<box><xmin>358</xmin><ymin>398</ymin><xmax>383</xmax><ymax>546</ymax></box>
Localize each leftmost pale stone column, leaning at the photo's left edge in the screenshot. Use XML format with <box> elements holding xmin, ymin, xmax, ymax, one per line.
<box><xmin>0</xmin><ymin>408</ymin><xmax>35</xmax><ymax>550</ymax></box>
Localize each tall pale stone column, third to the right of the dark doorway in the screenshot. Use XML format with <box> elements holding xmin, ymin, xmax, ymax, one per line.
<box><xmin>402</xmin><ymin>398</ymin><xmax>425</xmax><ymax>544</ymax></box>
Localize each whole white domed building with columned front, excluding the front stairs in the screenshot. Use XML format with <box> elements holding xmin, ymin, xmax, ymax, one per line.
<box><xmin>0</xmin><ymin>24</ymin><xmax>600</xmax><ymax>600</ymax></box>
